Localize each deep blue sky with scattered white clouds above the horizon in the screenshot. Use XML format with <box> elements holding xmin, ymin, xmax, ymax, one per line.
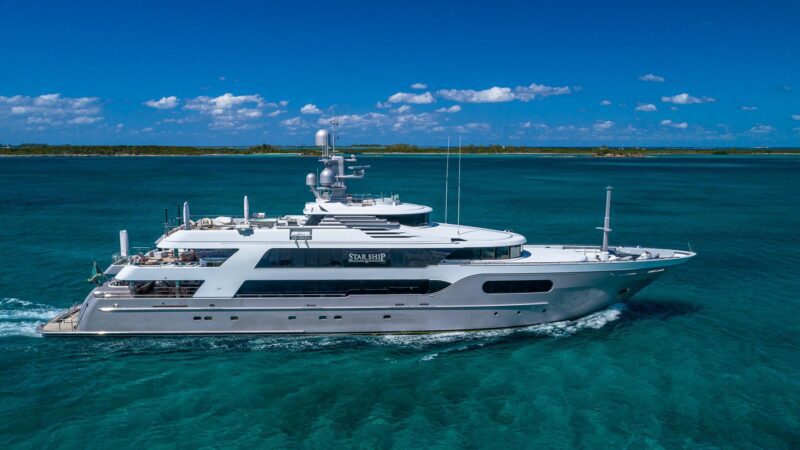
<box><xmin>0</xmin><ymin>0</ymin><xmax>800</xmax><ymax>146</ymax></box>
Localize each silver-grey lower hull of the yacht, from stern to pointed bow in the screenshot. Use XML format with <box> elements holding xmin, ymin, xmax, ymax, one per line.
<box><xmin>39</xmin><ymin>261</ymin><xmax>676</xmax><ymax>336</ymax></box>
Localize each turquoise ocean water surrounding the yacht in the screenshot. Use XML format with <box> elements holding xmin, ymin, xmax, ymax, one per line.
<box><xmin>0</xmin><ymin>156</ymin><xmax>800</xmax><ymax>449</ymax></box>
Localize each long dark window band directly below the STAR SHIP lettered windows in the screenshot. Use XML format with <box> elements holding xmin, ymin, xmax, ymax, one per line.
<box><xmin>236</xmin><ymin>280</ymin><xmax>450</xmax><ymax>297</ymax></box>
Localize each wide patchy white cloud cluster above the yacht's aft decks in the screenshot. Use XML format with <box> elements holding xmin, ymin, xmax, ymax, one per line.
<box><xmin>183</xmin><ymin>93</ymin><xmax>274</xmax><ymax>128</ymax></box>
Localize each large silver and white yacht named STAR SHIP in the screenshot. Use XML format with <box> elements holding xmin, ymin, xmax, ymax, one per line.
<box><xmin>38</xmin><ymin>126</ymin><xmax>695</xmax><ymax>336</ymax></box>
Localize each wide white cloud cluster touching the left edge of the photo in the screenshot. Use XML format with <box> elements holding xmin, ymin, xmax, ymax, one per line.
<box><xmin>0</xmin><ymin>94</ymin><xmax>103</xmax><ymax>125</ymax></box>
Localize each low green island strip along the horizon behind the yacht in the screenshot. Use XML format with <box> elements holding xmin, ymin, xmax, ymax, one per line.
<box><xmin>0</xmin><ymin>144</ymin><xmax>800</xmax><ymax>158</ymax></box>
